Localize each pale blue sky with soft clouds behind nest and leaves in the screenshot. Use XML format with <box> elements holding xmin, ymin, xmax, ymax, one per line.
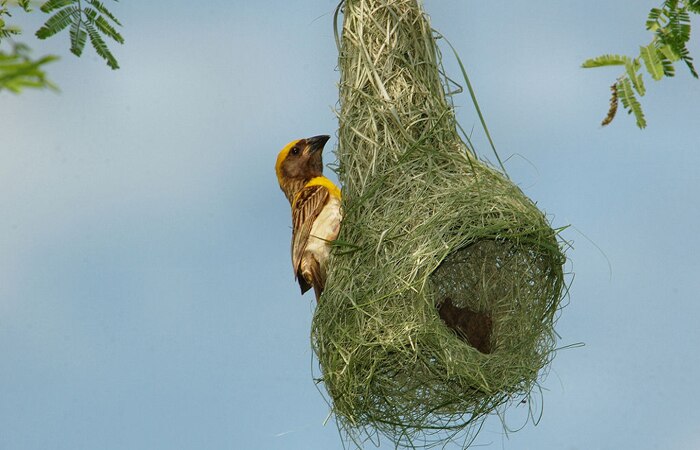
<box><xmin>0</xmin><ymin>0</ymin><xmax>700</xmax><ymax>450</ymax></box>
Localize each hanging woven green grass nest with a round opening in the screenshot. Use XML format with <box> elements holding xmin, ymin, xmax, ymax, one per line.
<box><xmin>312</xmin><ymin>0</ymin><xmax>565</xmax><ymax>447</ymax></box>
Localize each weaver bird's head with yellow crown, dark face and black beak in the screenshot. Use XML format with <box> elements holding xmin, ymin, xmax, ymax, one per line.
<box><xmin>275</xmin><ymin>135</ymin><xmax>331</xmax><ymax>191</ymax></box>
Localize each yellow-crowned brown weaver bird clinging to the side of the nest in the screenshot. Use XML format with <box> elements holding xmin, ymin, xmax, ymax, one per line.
<box><xmin>275</xmin><ymin>135</ymin><xmax>342</xmax><ymax>302</ymax></box>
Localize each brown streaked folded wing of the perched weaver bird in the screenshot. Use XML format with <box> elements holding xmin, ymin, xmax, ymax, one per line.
<box><xmin>292</xmin><ymin>185</ymin><xmax>330</xmax><ymax>276</ymax></box>
